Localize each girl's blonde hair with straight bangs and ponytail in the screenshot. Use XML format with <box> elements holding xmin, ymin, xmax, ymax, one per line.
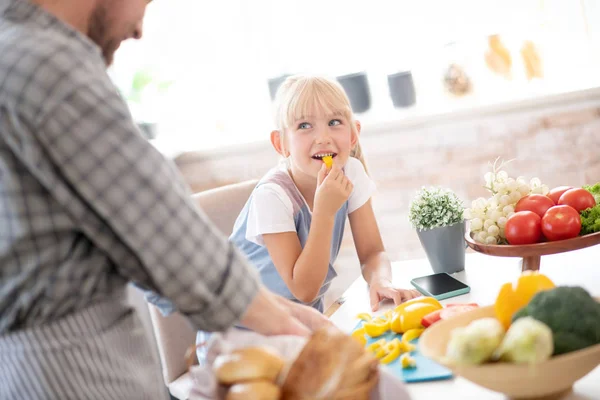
<box><xmin>275</xmin><ymin>75</ymin><xmax>367</xmax><ymax>171</ymax></box>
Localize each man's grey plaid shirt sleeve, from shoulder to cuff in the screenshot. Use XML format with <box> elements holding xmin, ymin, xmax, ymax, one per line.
<box><xmin>32</xmin><ymin>71</ymin><xmax>259</xmax><ymax>330</ymax></box>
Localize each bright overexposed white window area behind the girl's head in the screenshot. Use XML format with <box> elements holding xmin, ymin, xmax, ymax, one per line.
<box><xmin>111</xmin><ymin>0</ymin><xmax>600</xmax><ymax>155</ymax></box>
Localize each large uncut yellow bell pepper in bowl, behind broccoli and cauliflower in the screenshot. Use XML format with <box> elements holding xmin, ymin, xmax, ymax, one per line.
<box><xmin>494</xmin><ymin>271</ymin><xmax>555</xmax><ymax>329</ymax></box>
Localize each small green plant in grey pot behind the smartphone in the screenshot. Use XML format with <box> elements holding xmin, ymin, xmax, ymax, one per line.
<box><xmin>408</xmin><ymin>187</ymin><xmax>465</xmax><ymax>273</ymax></box>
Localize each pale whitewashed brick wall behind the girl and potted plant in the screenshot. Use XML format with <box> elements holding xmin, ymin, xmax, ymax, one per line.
<box><xmin>176</xmin><ymin>96</ymin><xmax>600</xmax><ymax>306</ymax></box>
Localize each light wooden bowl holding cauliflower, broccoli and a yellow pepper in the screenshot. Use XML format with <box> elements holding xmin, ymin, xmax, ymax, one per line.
<box><xmin>419</xmin><ymin>306</ymin><xmax>600</xmax><ymax>399</ymax></box>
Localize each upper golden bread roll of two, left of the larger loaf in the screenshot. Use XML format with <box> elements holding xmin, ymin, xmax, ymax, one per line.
<box><xmin>213</xmin><ymin>347</ymin><xmax>284</xmax><ymax>385</ymax></box>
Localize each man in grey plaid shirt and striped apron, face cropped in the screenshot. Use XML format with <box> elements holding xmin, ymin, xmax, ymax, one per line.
<box><xmin>0</xmin><ymin>0</ymin><xmax>324</xmax><ymax>399</ymax></box>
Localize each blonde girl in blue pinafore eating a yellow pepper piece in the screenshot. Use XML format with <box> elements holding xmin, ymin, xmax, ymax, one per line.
<box><xmin>230</xmin><ymin>76</ymin><xmax>419</xmax><ymax>312</ymax></box>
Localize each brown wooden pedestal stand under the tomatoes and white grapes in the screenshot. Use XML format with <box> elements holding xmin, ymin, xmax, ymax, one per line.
<box><xmin>465</xmin><ymin>232</ymin><xmax>600</xmax><ymax>271</ymax></box>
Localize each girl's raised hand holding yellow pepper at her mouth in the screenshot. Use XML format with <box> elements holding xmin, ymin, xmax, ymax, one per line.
<box><xmin>314</xmin><ymin>159</ymin><xmax>354</xmax><ymax>216</ymax></box>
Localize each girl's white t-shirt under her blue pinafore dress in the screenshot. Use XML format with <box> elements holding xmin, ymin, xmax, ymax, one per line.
<box><xmin>246</xmin><ymin>157</ymin><xmax>375</xmax><ymax>246</ymax></box>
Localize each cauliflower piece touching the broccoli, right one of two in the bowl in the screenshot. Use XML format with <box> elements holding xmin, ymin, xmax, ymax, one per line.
<box><xmin>497</xmin><ymin>317</ymin><xmax>554</xmax><ymax>364</ymax></box>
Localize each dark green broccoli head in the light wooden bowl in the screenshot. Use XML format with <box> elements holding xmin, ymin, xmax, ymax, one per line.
<box><xmin>513</xmin><ymin>286</ymin><xmax>600</xmax><ymax>355</ymax></box>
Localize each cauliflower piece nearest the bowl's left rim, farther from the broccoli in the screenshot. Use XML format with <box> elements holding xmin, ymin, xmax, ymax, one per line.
<box><xmin>446</xmin><ymin>318</ymin><xmax>505</xmax><ymax>365</ymax></box>
